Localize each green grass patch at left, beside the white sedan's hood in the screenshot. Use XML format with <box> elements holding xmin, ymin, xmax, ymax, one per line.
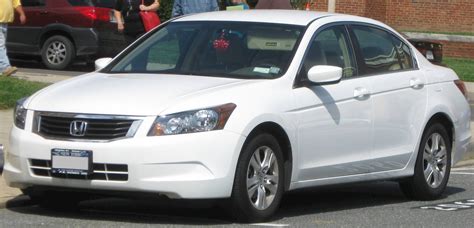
<box><xmin>0</xmin><ymin>75</ymin><xmax>49</xmax><ymax>109</ymax></box>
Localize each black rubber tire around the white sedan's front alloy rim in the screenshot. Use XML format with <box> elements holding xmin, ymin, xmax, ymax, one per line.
<box><xmin>230</xmin><ymin>133</ymin><xmax>285</xmax><ymax>222</ymax></box>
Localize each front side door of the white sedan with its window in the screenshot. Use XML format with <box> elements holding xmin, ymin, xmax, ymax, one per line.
<box><xmin>294</xmin><ymin>25</ymin><xmax>373</xmax><ymax>181</ymax></box>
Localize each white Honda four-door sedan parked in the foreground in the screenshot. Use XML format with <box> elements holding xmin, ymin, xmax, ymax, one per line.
<box><xmin>4</xmin><ymin>10</ymin><xmax>471</xmax><ymax>221</ymax></box>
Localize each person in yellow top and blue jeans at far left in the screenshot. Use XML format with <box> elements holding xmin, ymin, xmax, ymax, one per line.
<box><xmin>0</xmin><ymin>0</ymin><xmax>26</xmax><ymax>76</ymax></box>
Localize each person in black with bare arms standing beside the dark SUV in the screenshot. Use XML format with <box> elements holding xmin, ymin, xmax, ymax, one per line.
<box><xmin>114</xmin><ymin>0</ymin><xmax>160</xmax><ymax>45</ymax></box>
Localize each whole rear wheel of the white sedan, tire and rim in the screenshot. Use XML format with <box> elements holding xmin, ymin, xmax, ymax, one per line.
<box><xmin>400</xmin><ymin>123</ymin><xmax>451</xmax><ymax>200</ymax></box>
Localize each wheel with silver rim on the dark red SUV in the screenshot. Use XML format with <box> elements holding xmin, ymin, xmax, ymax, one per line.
<box><xmin>41</xmin><ymin>35</ymin><xmax>76</xmax><ymax>70</ymax></box>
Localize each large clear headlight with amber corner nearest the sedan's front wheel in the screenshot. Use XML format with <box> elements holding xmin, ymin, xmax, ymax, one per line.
<box><xmin>148</xmin><ymin>104</ymin><xmax>236</xmax><ymax>136</ymax></box>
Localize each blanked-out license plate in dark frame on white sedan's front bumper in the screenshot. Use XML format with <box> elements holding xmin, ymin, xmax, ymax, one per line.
<box><xmin>51</xmin><ymin>149</ymin><xmax>92</xmax><ymax>176</ymax></box>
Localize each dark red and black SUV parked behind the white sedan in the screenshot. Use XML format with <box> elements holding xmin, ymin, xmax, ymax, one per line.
<box><xmin>7</xmin><ymin>0</ymin><xmax>125</xmax><ymax>69</ymax></box>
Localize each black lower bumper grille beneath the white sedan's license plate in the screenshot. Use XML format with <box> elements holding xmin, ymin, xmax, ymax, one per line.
<box><xmin>30</xmin><ymin>159</ymin><xmax>128</xmax><ymax>181</ymax></box>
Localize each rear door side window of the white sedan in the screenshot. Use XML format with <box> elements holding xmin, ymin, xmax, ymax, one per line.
<box><xmin>352</xmin><ymin>25</ymin><xmax>403</xmax><ymax>74</ymax></box>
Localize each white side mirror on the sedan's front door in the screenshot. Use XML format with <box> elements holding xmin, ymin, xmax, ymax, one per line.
<box><xmin>308</xmin><ymin>65</ymin><xmax>342</xmax><ymax>84</ymax></box>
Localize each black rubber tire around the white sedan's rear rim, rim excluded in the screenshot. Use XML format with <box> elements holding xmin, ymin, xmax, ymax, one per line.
<box><xmin>399</xmin><ymin>123</ymin><xmax>452</xmax><ymax>200</ymax></box>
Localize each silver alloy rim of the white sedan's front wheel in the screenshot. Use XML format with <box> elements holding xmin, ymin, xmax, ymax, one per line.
<box><xmin>247</xmin><ymin>146</ymin><xmax>279</xmax><ymax>210</ymax></box>
